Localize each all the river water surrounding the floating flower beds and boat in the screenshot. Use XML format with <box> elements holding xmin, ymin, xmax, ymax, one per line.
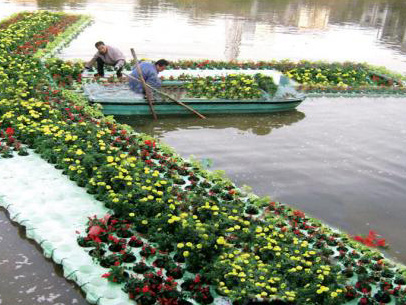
<box><xmin>0</xmin><ymin>0</ymin><xmax>406</xmax><ymax>305</ymax></box>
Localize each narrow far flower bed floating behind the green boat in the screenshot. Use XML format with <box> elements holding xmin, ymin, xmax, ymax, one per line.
<box><xmin>159</xmin><ymin>60</ymin><xmax>406</xmax><ymax>94</ymax></box>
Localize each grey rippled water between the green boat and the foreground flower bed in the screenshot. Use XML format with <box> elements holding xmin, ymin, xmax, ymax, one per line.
<box><xmin>118</xmin><ymin>98</ymin><xmax>406</xmax><ymax>263</ymax></box>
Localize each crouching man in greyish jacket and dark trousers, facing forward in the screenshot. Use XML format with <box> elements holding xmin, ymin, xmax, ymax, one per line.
<box><xmin>85</xmin><ymin>41</ymin><xmax>125</xmax><ymax>77</ymax></box>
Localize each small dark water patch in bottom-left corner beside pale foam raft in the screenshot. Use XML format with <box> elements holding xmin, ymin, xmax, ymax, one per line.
<box><xmin>0</xmin><ymin>208</ymin><xmax>88</xmax><ymax>305</ymax></box>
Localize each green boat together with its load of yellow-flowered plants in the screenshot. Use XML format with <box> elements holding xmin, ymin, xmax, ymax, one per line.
<box><xmin>83</xmin><ymin>70</ymin><xmax>305</xmax><ymax>115</ymax></box>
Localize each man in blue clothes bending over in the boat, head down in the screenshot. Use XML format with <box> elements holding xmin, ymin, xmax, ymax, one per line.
<box><xmin>129</xmin><ymin>59</ymin><xmax>169</xmax><ymax>93</ymax></box>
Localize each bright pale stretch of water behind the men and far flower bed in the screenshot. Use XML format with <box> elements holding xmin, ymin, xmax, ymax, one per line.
<box><xmin>0</xmin><ymin>0</ymin><xmax>406</xmax><ymax>72</ymax></box>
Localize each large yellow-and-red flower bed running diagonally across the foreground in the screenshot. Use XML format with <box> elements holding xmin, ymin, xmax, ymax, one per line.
<box><xmin>0</xmin><ymin>13</ymin><xmax>406</xmax><ymax>304</ymax></box>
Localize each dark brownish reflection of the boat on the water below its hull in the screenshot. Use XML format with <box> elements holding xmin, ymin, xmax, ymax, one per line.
<box><xmin>115</xmin><ymin>110</ymin><xmax>305</xmax><ymax>137</ymax></box>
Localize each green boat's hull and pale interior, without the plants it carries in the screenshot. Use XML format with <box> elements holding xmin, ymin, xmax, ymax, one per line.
<box><xmin>83</xmin><ymin>69</ymin><xmax>306</xmax><ymax>116</ymax></box>
